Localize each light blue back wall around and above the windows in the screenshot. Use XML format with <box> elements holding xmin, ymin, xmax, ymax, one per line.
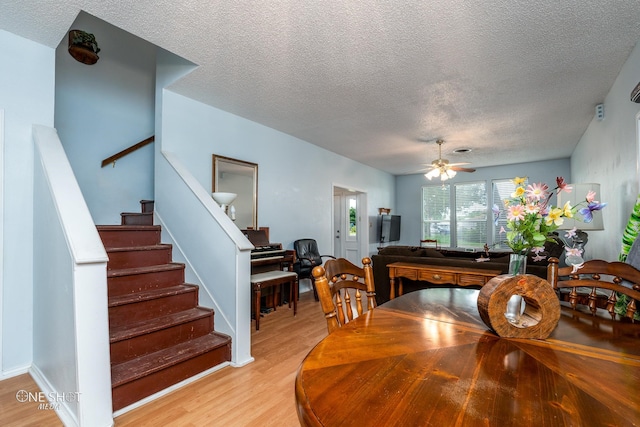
<box><xmin>396</xmin><ymin>159</ymin><xmax>571</xmax><ymax>246</ymax></box>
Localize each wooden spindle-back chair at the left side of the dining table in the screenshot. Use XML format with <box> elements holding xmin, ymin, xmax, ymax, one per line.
<box><xmin>313</xmin><ymin>258</ymin><xmax>376</xmax><ymax>333</ymax></box>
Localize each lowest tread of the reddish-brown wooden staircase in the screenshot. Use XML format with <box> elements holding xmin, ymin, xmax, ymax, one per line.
<box><xmin>111</xmin><ymin>332</ymin><xmax>231</xmax><ymax>388</ymax></box>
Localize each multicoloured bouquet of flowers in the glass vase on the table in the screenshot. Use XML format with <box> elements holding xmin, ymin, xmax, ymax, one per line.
<box><xmin>494</xmin><ymin>177</ymin><xmax>607</xmax><ymax>265</ymax></box>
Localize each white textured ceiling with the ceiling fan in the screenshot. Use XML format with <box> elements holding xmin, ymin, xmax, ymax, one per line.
<box><xmin>0</xmin><ymin>0</ymin><xmax>640</xmax><ymax>174</ymax></box>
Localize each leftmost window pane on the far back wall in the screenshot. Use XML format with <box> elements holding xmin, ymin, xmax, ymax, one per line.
<box><xmin>422</xmin><ymin>184</ymin><xmax>451</xmax><ymax>246</ymax></box>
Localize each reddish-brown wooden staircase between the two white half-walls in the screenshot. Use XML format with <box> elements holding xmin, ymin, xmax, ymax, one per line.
<box><xmin>97</xmin><ymin>201</ymin><xmax>231</xmax><ymax>411</ymax></box>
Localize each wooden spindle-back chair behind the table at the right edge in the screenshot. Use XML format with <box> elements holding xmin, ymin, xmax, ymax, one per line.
<box><xmin>547</xmin><ymin>257</ymin><xmax>640</xmax><ymax>319</ymax></box>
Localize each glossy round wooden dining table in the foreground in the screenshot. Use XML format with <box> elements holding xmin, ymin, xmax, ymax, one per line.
<box><xmin>295</xmin><ymin>288</ymin><xmax>640</xmax><ymax>427</ymax></box>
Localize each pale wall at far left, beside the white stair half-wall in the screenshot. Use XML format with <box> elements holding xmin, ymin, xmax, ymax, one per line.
<box><xmin>0</xmin><ymin>30</ymin><xmax>55</xmax><ymax>377</ymax></box>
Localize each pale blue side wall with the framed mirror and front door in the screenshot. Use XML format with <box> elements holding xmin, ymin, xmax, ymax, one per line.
<box><xmin>162</xmin><ymin>91</ymin><xmax>394</xmax><ymax>253</ymax></box>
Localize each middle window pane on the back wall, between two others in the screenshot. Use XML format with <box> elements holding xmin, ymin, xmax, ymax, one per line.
<box><xmin>455</xmin><ymin>181</ymin><xmax>489</xmax><ymax>248</ymax></box>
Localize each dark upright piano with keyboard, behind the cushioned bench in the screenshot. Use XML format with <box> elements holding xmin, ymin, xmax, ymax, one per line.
<box><xmin>241</xmin><ymin>231</ymin><xmax>295</xmax><ymax>313</ymax></box>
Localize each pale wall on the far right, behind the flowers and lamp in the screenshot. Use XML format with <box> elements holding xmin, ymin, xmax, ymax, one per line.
<box><xmin>571</xmin><ymin>41</ymin><xmax>640</xmax><ymax>261</ymax></box>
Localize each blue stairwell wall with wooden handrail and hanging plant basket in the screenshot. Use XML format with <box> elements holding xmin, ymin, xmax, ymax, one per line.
<box><xmin>55</xmin><ymin>13</ymin><xmax>156</xmax><ymax>224</ymax></box>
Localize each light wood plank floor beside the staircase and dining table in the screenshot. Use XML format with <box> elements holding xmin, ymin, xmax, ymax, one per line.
<box><xmin>0</xmin><ymin>292</ymin><xmax>327</xmax><ymax>427</ymax></box>
